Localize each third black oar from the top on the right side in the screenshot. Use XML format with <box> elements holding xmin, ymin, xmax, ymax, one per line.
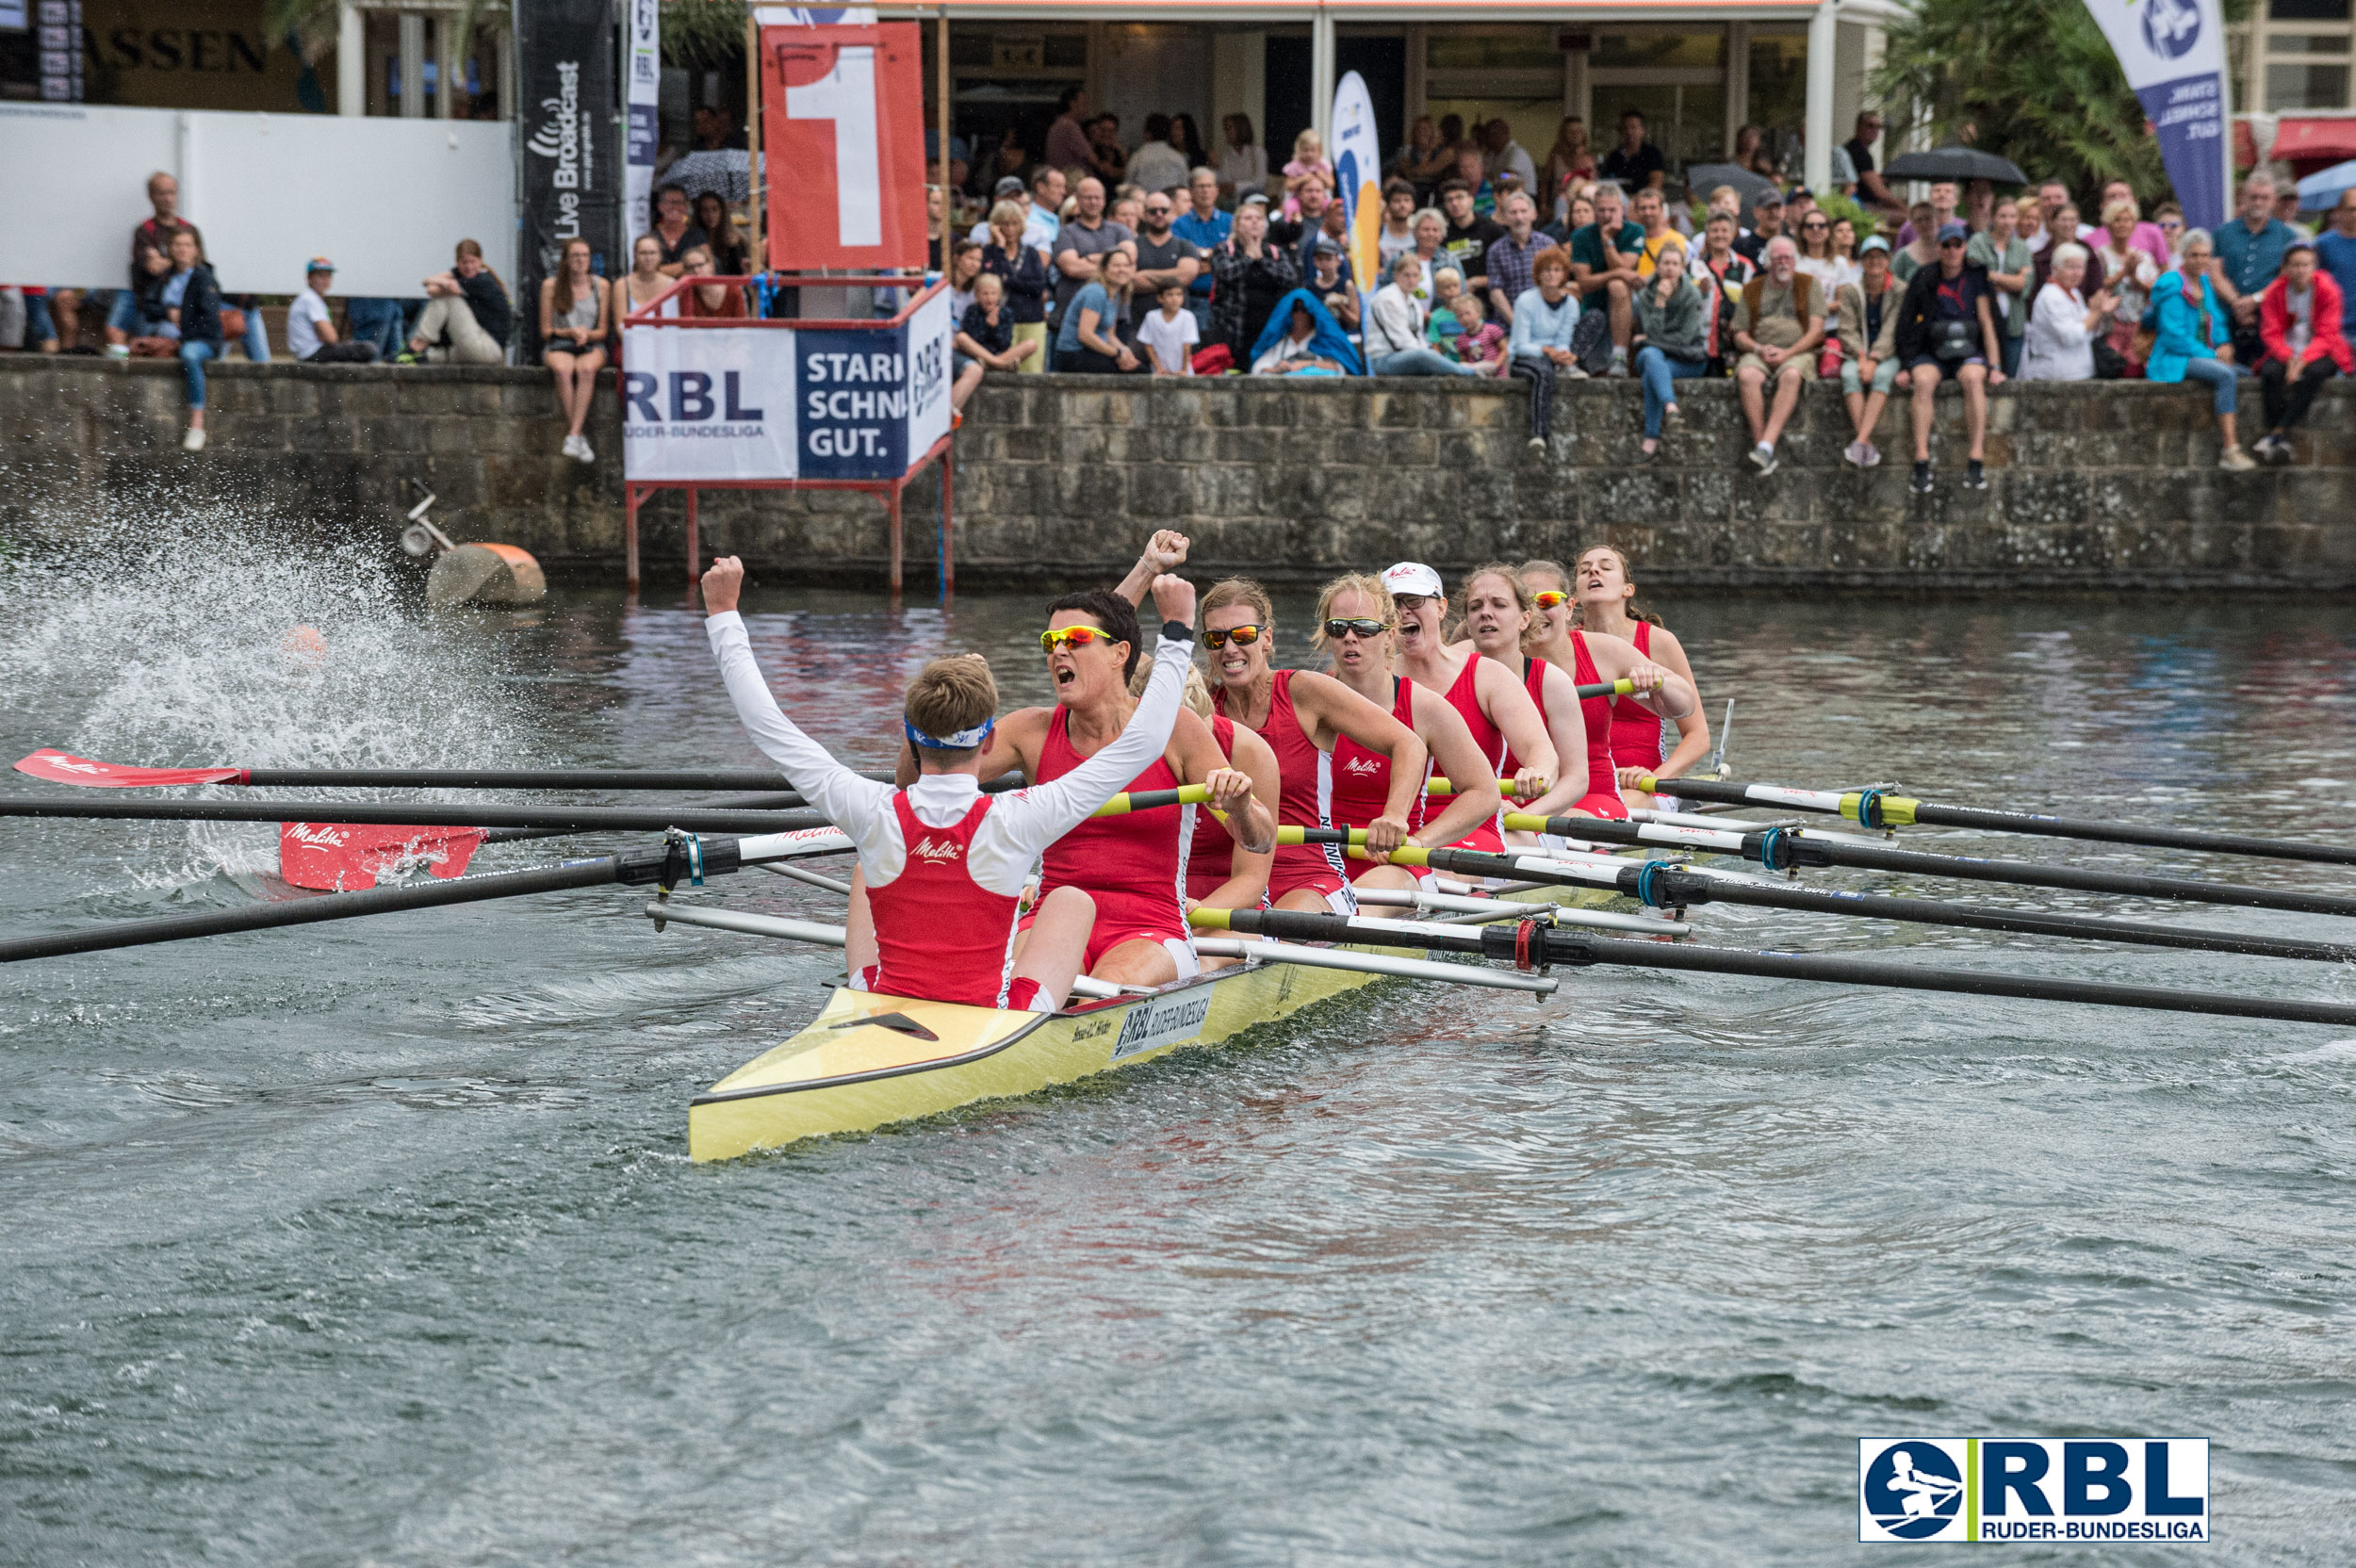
<box><xmin>1352</xmin><ymin>850</ymin><xmax>2356</xmax><ymax>963</ymax></box>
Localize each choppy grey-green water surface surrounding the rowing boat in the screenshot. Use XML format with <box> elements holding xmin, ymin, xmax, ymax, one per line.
<box><xmin>0</xmin><ymin>534</ymin><xmax>2356</xmax><ymax>1566</ymax></box>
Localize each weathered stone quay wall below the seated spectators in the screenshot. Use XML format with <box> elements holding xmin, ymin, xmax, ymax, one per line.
<box><xmin>0</xmin><ymin>355</ymin><xmax>2356</xmax><ymax>591</ymax></box>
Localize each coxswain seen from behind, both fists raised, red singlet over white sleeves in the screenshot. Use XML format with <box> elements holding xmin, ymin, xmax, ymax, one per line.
<box><xmin>702</xmin><ymin>556</ymin><xmax>1195</xmax><ymax>1012</ymax></box>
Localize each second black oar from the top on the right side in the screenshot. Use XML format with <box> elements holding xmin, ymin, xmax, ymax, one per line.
<box><xmin>1506</xmin><ymin>812</ymin><xmax>2356</xmax><ymax>916</ymax></box>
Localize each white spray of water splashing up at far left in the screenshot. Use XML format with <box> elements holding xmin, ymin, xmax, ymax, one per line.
<box><xmin>0</xmin><ymin>504</ymin><xmax>535</xmax><ymax>888</ymax></box>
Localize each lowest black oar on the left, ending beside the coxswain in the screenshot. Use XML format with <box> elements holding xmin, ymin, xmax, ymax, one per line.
<box><xmin>0</xmin><ymin>828</ymin><xmax>851</xmax><ymax>963</ymax></box>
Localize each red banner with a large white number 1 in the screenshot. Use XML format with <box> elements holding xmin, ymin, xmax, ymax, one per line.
<box><xmin>761</xmin><ymin>21</ymin><xmax>926</xmax><ymax>270</ymax></box>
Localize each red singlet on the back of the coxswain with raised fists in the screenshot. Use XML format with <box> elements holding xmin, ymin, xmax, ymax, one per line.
<box><xmin>860</xmin><ymin>789</ymin><xmax>1030</xmax><ymax>1007</ymax></box>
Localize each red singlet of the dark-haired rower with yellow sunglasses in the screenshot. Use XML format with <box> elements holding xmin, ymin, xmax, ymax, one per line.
<box><xmin>1037</xmin><ymin>707</ymin><xmax>1195</xmax><ymax>968</ymax></box>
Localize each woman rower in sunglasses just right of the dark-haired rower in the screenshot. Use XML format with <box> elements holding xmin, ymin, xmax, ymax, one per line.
<box><xmin>1202</xmin><ymin>577</ymin><xmax>1431</xmax><ymax>913</ymax></box>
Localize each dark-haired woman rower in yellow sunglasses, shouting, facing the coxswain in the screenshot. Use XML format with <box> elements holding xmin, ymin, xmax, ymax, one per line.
<box><xmin>952</xmin><ymin>580</ymin><xmax>1252</xmax><ymax>987</ymax></box>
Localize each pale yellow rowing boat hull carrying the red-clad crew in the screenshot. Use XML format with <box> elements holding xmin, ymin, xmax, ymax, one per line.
<box><xmin>688</xmin><ymin>888</ymin><xmax>1612</xmax><ymax>1161</ymax></box>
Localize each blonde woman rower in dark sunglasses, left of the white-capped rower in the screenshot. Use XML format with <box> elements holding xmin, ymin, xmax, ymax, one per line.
<box><xmin>1310</xmin><ymin>572</ymin><xmax>1498</xmax><ymax>888</ymax></box>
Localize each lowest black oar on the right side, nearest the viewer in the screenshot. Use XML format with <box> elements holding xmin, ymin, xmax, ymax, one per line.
<box><xmin>1187</xmin><ymin>908</ymin><xmax>2356</xmax><ymax>1024</ymax></box>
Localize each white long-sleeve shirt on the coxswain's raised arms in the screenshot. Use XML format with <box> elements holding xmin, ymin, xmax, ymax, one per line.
<box><xmin>705</xmin><ymin>610</ymin><xmax>1195</xmax><ymax>897</ymax></box>
